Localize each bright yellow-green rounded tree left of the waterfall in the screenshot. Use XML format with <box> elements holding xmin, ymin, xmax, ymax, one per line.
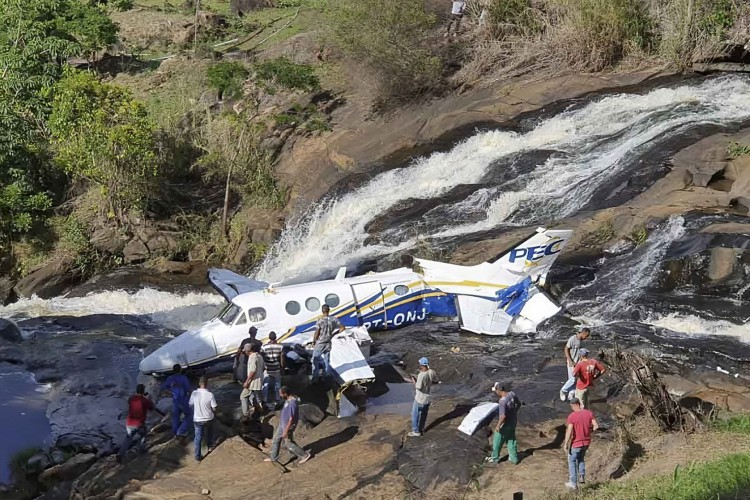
<box><xmin>49</xmin><ymin>71</ymin><xmax>160</xmax><ymax>222</ymax></box>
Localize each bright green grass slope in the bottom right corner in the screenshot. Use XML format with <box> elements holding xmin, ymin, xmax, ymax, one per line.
<box><xmin>576</xmin><ymin>453</ymin><xmax>750</xmax><ymax>500</ymax></box>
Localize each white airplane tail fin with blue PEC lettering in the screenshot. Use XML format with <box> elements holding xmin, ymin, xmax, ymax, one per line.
<box><xmin>484</xmin><ymin>227</ymin><xmax>573</xmax><ymax>285</ymax></box>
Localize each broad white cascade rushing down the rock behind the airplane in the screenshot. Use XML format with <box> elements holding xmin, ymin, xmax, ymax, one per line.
<box><xmin>256</xmin><ymin>77</ymin><xmax>750</xmax><ymax>281</ymax></box>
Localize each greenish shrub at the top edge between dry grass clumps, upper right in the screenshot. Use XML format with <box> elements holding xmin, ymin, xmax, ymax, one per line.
<box><xmin>560</xmin><ymin>0</ymin><xmax>657</xmax><ymax>71</ymax></box>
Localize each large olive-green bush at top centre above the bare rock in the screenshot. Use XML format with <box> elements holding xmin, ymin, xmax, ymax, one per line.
<box><xmin>325</xmin><ymin>0</ymin><xmax>443</xmax><ymax>95</ymax></box>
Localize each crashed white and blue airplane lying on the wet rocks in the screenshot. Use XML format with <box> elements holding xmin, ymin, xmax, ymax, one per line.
<box><xmin>140</xmin><ymin>228</ymin><xmax>573</xmax><ymax>374</ymax></box>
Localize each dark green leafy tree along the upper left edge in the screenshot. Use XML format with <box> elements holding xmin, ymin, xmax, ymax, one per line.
<box><xmin>0</xmin><ymin>0</ymin><xmax>117</xmax><ymax>248</ymax></box>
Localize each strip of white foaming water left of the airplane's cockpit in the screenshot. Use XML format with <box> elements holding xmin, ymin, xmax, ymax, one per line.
<box><xmin>0</xmin><ymin>288</ymin><xmax>223</xmax><ymax>329</ymax></box>
